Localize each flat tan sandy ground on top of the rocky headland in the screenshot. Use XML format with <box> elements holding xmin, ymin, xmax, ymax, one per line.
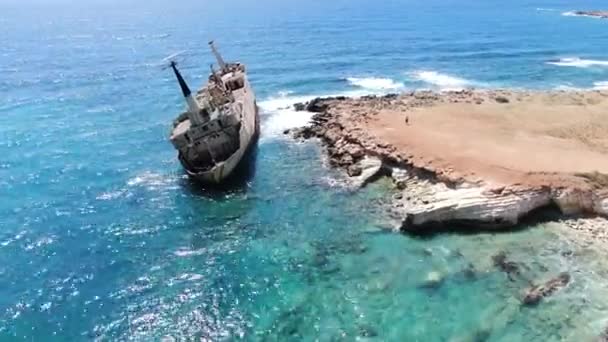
<box><xmin>364</xmin><ymin>91</ymin><xmax>608</xmax><ymax>185</ymax></box>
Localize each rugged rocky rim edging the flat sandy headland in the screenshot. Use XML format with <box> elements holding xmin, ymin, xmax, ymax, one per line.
<box><xmin>285</xmin><ymin>90</ymin><xmax>608</xmax><ymax>234</ymax></box>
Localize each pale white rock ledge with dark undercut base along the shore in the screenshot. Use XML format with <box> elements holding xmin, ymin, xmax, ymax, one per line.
<box><xmin>384</xmin><ymin>164</ymin><xmax>608</xmax><ymax>234</ymax></box>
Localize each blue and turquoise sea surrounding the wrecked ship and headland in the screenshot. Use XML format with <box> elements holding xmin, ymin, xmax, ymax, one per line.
<box><xmin>0</xmin><ymin>0</ymin><xmax>608</xmax><ymax>341</ymax></box>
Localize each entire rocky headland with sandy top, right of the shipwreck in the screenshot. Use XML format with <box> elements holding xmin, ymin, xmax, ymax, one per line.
<box><xmin>286</xmin><ymin>90</ymin><xmax>608</xmax><ymax>234</ymax></box>
